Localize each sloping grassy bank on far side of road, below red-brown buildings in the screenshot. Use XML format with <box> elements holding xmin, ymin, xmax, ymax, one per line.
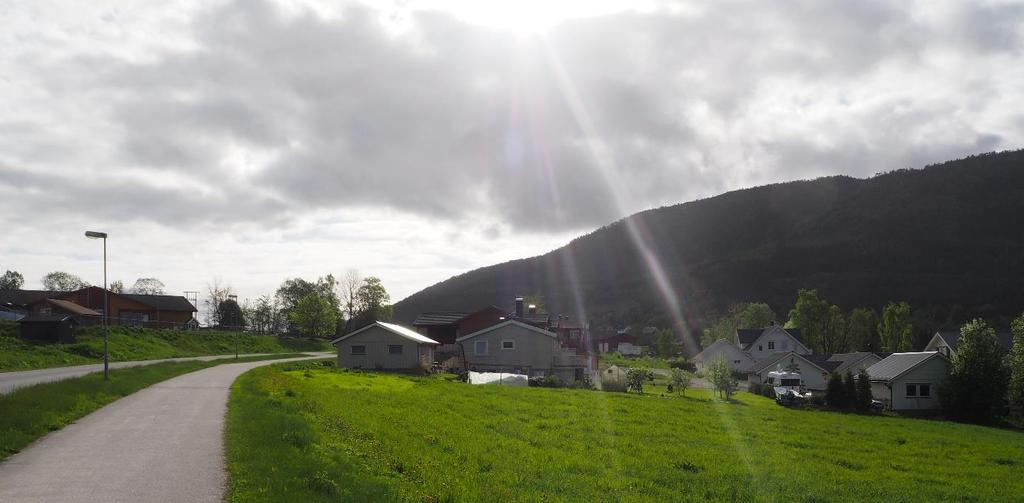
<box><xmin>0</xmin><ymin>322</ymin><xmax>333</xmax><ymax>372</ymax></box>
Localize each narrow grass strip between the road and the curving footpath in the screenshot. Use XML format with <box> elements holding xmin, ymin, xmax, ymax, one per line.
<box><xmin>0</xmin><ymin>354</ymin><xmax>311</xmax><ymax>460</ymax></box>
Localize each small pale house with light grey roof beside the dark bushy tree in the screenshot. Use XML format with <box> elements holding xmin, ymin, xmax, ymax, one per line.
<box><xmin>867</xmin><ymin>351</ymin><xmax>949</xmax><ymax>411</ymax></box>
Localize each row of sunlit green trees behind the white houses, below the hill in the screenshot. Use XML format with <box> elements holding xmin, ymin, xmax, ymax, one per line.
<box><xmin>700</xmin><ymin>289</ymin><xmax>937</xmax><ymax>354</ymax></box>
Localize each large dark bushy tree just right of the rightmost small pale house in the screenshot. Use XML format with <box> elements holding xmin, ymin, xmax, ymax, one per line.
<box><xmin>939</xmin><ymin>319</ymin><xmax>1009</xmax><ymax>422</ymax></box>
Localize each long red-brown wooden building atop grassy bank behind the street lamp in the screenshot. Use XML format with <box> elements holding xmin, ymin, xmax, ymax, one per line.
<box><xmin>27</xmin><ymin>287</ymin><xmax>197</xmax><ymax>328</ymax></box>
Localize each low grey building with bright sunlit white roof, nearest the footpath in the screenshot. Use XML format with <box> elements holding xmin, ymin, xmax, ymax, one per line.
<box><xmin>331</xmin><ymin>322</ymin><xmax>438</xmax><ymax>371</ymax></box>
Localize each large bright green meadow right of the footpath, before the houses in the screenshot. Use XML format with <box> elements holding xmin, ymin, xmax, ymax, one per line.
<box><xmin>226</xmin><ymin>364</ymin><xmax>1024</xmax><ymax>502</ymax></box>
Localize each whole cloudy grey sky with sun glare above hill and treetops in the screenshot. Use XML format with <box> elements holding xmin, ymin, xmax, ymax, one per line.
<box><xmin>0</xmin><ymin>0</ymin><xmax>1024</xmax><ymax>300</ymax></box>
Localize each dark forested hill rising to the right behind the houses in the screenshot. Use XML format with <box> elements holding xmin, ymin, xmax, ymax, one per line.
<box><xmin>394</xmin><ymin>151</ymin><xmax>1024</xmax><ymax>328</ymax></box>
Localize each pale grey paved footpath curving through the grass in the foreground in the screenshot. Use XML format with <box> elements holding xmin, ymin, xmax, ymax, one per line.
<box><xmin>0</xmin><ymin>353</ymin><xmax>330</xmax><ymax>503</ymax></box>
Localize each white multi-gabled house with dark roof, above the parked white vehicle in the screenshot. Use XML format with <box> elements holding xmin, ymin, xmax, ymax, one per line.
<box><xmin>693</xmin><ymin>325</ymin><xmax>813</xmax><ymax>372</ymax></box>
